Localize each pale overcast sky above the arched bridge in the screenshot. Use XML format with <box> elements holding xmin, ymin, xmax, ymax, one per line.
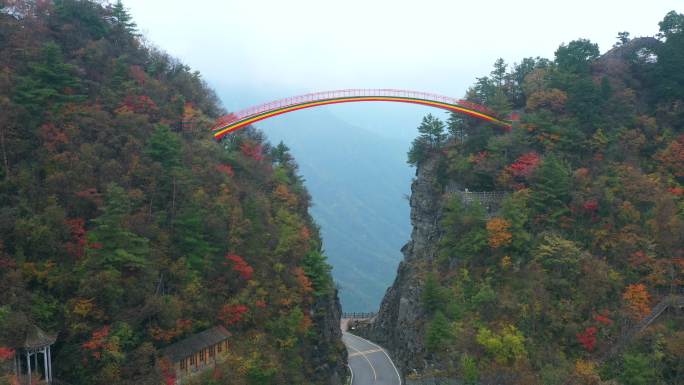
<box><xmin>124</xmin><ymin>0</ymin><xmax>684</xmax><ymax>137</ymax></box>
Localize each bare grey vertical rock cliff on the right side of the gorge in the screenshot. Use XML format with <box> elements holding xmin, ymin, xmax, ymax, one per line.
<box><xmin>367</xmin><ymin>159</ymin><xmax>442</xmax><ymax>375</ymax></box>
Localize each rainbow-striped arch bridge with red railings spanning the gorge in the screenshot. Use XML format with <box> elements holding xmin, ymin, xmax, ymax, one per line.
<box><xmin>212</xmin><ymin>89</ymin><xmax>511</xmax><ymax>139</ymax></box>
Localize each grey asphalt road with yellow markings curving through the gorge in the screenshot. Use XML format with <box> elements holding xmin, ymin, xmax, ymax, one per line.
<box><xmin>342</xmin><ymin>332</ymin><xmax>402</xmax><ymax>385</ymax></box>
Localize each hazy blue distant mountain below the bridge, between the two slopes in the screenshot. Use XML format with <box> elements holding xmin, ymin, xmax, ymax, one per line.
<box><xmin>257</xmin><ymin>107</ymin><xmax>417</xmax><ymax>311</ymax></box>
